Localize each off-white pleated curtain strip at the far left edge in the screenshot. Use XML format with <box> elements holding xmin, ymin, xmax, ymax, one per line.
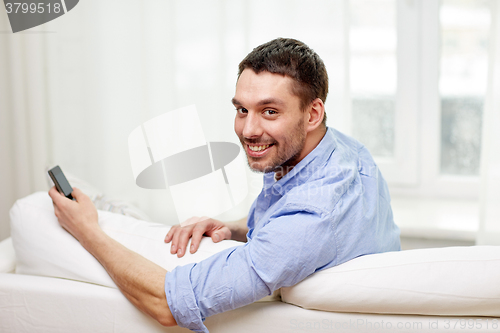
<box><xmin>0</xmin><ymin>13</ymin><xmax>49</xmax><ymax>240</ymax></box>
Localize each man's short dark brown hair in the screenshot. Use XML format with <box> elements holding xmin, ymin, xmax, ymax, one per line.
<box><xmin>238</xmin><ymin>38</ymin><xmax>328</xmax><ymax>124</ymax></box>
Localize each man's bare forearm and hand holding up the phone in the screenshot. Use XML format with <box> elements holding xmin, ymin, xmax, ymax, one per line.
<box><xmin>49</xmin><ymin>187</ymin><xmax>177</xmax><ymax>326</ymax></box>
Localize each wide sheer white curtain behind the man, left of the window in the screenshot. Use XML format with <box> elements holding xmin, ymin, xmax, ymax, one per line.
<box><xmin>0</xmin><ymin>0</ymin><xmax>349</xmax><ymax>239</ymax></box>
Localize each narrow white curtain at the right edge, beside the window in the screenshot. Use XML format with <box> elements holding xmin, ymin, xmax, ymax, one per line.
<box><xmin>476</xmin><ymin>1</ymin><xmax>500</xmax><ymax>245</ymax></box>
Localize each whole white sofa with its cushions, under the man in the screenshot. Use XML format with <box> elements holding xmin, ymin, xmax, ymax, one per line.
<box><xmin>0</xmin><ymin>194</ymin><xmax>500</xmax><ymax>332</ymax></box>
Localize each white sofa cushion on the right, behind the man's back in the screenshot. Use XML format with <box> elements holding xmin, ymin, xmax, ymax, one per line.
<box><xmin>281</xmin><ymin>246</ymin><xmax>500</xmax><ymax>317</ymax></box>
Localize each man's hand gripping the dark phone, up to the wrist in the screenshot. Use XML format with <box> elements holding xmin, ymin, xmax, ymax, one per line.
<box><xmin>49</xmin><ymin>187</ymin><xmax>99</xmax><ymax>242</ymax></box>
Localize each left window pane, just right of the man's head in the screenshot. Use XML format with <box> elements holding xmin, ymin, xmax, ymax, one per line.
<box><xmin>349</xmin><ymin>0</ymin><xmax>397</xmax><ymax>156</ymax></box>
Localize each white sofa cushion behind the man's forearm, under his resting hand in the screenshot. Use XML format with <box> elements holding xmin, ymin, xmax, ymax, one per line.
<box><xmin>10</xmin><ymin>192</ymin><xmax>243</xmax><ymax>288</ymax></box>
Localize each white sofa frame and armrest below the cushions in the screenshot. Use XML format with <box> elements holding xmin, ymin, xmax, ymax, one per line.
<box><xmin>0</xmin><ymin>238</ymin><xmax>500</xmax><ymax>333</ymax></box>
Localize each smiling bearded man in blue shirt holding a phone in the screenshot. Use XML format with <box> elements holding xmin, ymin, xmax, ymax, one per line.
<box><xmin>49</xmin><ymin>38</ymin><xmax>400</xmax><ymax>332</ymax></box>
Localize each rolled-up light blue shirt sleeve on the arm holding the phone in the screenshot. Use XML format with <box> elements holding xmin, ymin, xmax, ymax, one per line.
<box><xmin>165</xmin><ymin>204</ymin><xmax>336</xmax><ymax>332</ymax></box>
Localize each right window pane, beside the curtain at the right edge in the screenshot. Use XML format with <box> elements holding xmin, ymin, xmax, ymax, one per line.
<box><xmin>439</xmin><ymin>0</ymin><xmax>491</xmax><ymax>175</ymax></box>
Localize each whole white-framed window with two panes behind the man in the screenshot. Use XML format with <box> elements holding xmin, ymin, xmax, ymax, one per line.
<box><xmin>348</xmin><ymin>0</ymin><xmax>491</xmax><ymax>199</ymax></box>
